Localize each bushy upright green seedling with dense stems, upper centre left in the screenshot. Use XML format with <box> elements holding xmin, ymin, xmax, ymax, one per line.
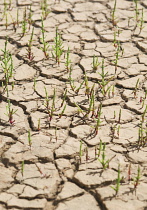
<box><xmin>52</xmin><ymin>28</ymin><xmax>64</xmax><ymax>65</ymax></box>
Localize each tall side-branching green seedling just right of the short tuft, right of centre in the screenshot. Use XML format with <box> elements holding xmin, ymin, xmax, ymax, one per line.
<box><xmin>98</xmin><ymin>59</ymin><xmax>113</xmax><ymax>97</ymax></box>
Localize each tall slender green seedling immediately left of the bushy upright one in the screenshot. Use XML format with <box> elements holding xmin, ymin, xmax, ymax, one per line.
<box><xmin>41</xmin><ymin>18</ymin><xmax>50</xmax><ymax>59</ymax></box>
